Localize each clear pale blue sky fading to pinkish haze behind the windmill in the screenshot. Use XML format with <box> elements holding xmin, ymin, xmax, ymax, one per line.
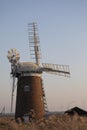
<box><xmin>0</xmin><ymin>0</ymin><xmax>87</xmax><ymax>112</ymax></box>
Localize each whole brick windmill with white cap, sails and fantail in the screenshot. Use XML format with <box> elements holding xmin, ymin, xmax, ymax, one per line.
<box><xmin>7</xmin><ymin>23</ymin><xmax>70</xmax><ymax>119</ymax></box>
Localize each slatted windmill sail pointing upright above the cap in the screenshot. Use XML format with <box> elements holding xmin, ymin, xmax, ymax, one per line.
<box><xmin>28</xmin><ymin>23</ymin><xmax>41</xmax><ymax>65</ymax></box>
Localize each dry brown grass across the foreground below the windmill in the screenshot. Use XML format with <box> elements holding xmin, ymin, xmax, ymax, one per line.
<box><xmin>0</xmin><ymin>115</ymin><xmax>87</xmax><ymax>130</ymax></box>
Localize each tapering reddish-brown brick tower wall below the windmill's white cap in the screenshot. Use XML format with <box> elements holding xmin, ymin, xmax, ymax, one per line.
<box><xmin>15</xmin><ymin>76</ymin><xmax>44</xmax><ymax>118</ymax></box>
